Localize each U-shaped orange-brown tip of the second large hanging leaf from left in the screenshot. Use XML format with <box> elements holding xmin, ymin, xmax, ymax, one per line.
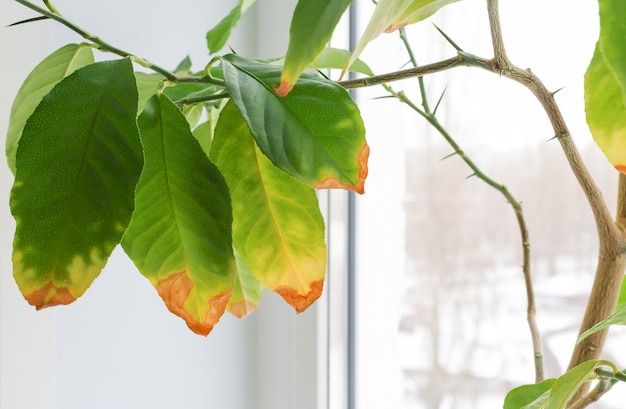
<box><xmin>155</xmin><ymin>271</ymin><xmax>232</xmax><ymax>336</ymax></box>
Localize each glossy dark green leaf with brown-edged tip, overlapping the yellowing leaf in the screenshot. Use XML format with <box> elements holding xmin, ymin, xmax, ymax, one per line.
<box><xmin>222</xmin><ymin>55</ymin><xmax>369</xmax><ymax>193</ymax></box>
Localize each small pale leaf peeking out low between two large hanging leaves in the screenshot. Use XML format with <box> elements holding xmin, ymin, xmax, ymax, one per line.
<box><xmin>226</xmin><ymin>251</ymin><xmax>263</xmax><ymax>318</ymax></box>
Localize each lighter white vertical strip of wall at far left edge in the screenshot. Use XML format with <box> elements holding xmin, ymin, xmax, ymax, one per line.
<box><xmin>0</xmin><ymin>0</ymin><xmax>56</xmax><ymax>409</ymax></box>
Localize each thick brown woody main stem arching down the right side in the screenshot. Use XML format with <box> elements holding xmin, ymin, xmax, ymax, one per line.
<box><xmin>340</xmin><ymin>0</ymin><xmax>626</xmax><ymax>400</ymax></box>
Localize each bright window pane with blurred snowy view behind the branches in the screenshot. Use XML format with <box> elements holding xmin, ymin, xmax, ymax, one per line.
<box><xmin>348</xmin><ymin>1</ymin><xmax>624</xmax><ymax>409</ymax></box>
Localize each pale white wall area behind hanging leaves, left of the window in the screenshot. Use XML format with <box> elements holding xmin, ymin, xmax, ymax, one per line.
<box><xmin>0</xmin><ymin>0</ymin><xmax>325</xmax><ymax>409</ymax></box>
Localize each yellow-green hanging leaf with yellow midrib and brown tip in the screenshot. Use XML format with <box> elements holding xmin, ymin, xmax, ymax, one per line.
<box><xmin>211</xmin><ymin>102</ymin><xmax>326</xmax><ymax>312</ymax></box>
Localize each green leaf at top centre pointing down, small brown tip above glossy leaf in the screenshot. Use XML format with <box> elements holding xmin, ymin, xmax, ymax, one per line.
<box><xmin>276</xmin><ymin>0</ymin><xmax>352</xmax><ymax>96</ymax></box>
